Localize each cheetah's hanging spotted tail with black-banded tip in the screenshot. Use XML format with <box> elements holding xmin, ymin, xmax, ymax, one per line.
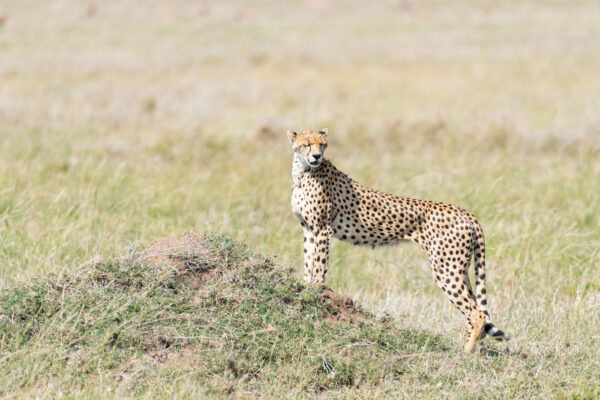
<box><xmin>473</xmin><ymin>218</ymin><xmax>510</xmax><ymax>341</ymax></box>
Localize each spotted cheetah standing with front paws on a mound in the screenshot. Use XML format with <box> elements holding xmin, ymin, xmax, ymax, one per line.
<box><xmin>287</xmin><ymin>129</ymin><xmax>509</xmax><ymax>353</ymax></box>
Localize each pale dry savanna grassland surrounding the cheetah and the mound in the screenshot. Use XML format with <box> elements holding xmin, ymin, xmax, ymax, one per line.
<box><xmin>0</xmin><ymin>0</ymin><xmax>600</xmax><ymax>398</ymax></box>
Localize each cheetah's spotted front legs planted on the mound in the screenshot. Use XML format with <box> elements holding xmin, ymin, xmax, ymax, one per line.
<box><xmin>304</xmin><ymin>227</ymin><xmax>333</xmax><ymax>285</ymax></box>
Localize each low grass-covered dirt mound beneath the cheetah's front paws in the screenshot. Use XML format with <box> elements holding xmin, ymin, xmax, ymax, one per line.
<box><xmin>5</xmin><ymin>234</ymin><xmax>454</xmax><ymax>397</ymax></box>
